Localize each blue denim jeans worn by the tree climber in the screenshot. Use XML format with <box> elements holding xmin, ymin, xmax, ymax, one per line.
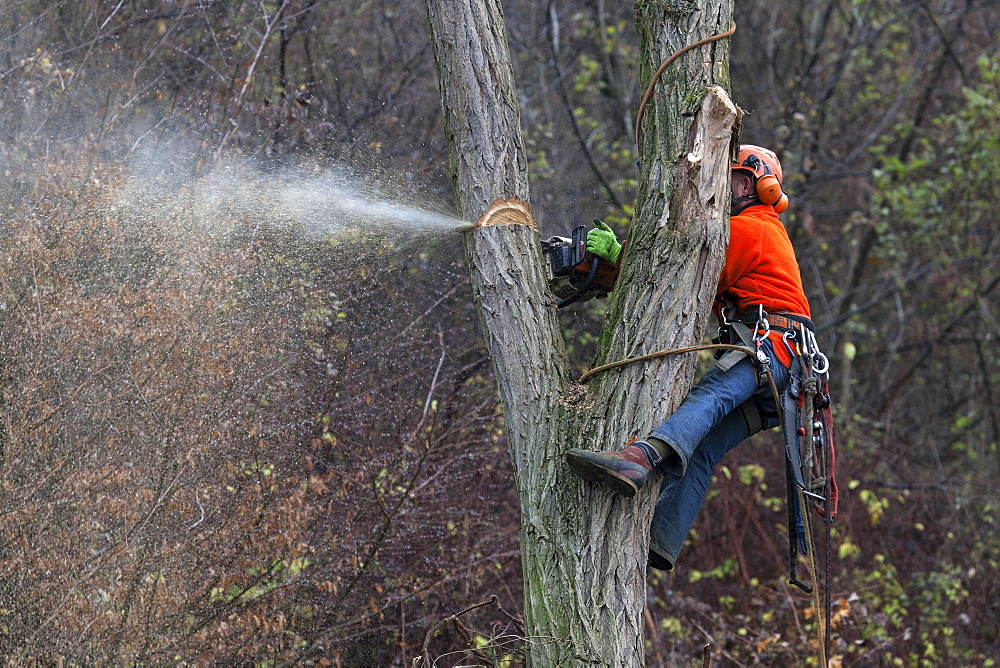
<box><xmin>649</xmin><ymin>342</ymin><xmax>789</xmax><ymax>570</ymax></box>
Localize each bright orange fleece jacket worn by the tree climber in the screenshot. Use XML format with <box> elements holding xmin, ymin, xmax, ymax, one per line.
<box><xmin>716</xmin><ymin>204</ymin><xmax>811</xmax><ymax>366</ymax></box>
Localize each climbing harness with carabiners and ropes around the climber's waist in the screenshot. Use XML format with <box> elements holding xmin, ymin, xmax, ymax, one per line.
<box><xmin>579</xmin><ymin>306</ymin><xmax>839</xmax><ymax>666</ymax></box>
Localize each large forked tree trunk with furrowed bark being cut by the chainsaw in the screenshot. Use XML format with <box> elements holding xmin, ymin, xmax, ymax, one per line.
<box><xmin>427</xmin><ymin>0</ymin><xmax>737</xmax><ymax>666</ymax></box>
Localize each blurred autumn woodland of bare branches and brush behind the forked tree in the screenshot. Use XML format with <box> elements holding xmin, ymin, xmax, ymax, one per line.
<box><xmin>0</xmin><ymin>0</ymin><xmax>1000</xmax><ymax>666</ymax></box>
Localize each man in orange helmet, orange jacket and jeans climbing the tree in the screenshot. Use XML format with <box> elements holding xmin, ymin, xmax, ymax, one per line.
<box><xmin>566</xmin><ymin>144</ymin><xmax>812</xmax><ymax>570</ymax></box>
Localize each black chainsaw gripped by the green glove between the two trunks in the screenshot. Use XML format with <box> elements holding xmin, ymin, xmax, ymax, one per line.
<box><xmin>542</xmin><ymin>225</ymin><xmax>618</xmax><ymax>308</ymax></box>
